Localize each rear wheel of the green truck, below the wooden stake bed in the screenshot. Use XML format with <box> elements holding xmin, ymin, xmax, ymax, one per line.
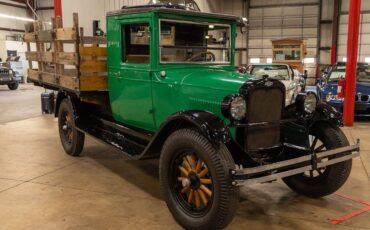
<box><xmin>58</xmin><ymin>99</ymin><xmax>85</xmax><ymax>157</ymax></box>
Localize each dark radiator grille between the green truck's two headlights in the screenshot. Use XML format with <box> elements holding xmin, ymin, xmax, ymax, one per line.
<box><xmin>245</xmin><ymin>88</ymin><xmax>285</xmax><ymax>151</ymax></box>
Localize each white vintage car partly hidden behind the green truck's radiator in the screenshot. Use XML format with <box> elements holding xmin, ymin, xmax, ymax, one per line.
<box><xmin>246</xmin><ymin>64</ymin><xmax>304</xmax><ymax>106</ymax></box>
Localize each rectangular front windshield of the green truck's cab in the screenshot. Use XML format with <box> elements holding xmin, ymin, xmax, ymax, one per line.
<box><xmin>160</xmin><ymin>20</ymin><xmax>231</xmax><ymax>64</ymax></box>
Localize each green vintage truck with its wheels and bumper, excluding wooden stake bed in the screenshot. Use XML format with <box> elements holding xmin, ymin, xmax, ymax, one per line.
<box><xmin>30</xmin><ymin>4</ymin><xmax>359</xmax><ymax>229</ymax></box>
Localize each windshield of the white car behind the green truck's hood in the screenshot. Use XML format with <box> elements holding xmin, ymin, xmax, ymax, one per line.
<box><xmin>251</xmin><ymin>65</ymin><xmax>289</xmax><ymax>80</ymax></box>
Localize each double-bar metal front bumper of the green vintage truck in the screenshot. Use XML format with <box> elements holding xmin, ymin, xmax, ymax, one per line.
<box><xmin>230</xmin><ymin>140</ymin><xmax>360</xmax><ymax>186</ymax></box>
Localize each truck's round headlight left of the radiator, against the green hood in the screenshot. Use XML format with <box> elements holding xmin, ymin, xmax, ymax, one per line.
<box><xmin>221</xmin><ymin>95</ymin><xmax>247</xmax><ymax>121</ymax></box>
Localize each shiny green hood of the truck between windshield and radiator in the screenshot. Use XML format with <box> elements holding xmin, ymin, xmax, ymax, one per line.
<box><xmin>158</xmin><ymin>67</ymin><xmax>252</xmax><ymax>117</ymax></box>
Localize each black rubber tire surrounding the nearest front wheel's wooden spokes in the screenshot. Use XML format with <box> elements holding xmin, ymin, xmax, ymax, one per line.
<box><xmin>159</xmin><ymin>129</ymin><xmax>239</xmax><ymax>229</ymax></box>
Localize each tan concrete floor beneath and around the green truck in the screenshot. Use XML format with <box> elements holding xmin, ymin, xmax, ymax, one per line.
<box><xmin>0</xmin><ymin>85</ymin><xmax>370</xmax><ymax>230</ymax></box>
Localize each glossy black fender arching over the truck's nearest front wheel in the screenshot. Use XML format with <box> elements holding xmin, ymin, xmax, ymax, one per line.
<box><xmin>144</xmin><ymin>110</ymin><xmax>231</xmax><ymax>157</ymax></box>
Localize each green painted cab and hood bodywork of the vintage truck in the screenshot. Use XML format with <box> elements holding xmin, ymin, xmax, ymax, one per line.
<box><xmin>107</xmin><ymin>10</ymin><xmax>252</xmax><ymax>132</ymax></box>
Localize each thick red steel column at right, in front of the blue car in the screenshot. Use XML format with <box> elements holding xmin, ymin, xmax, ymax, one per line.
<box><xmin>343</xmin><ymin>0</ymin><xmax>361</xmax><ymax>126</ymax></box>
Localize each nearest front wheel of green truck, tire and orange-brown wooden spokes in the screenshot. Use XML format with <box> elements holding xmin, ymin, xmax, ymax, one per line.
<box><xmin>159</xmin><ymin>129</ymin><xmax>239</xmax><ymax>229</ymax></box>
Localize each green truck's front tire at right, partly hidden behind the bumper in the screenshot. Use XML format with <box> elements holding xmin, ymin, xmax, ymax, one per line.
<box><xmin>283</xmin><ymin>123</ymin><xmax>352</xmax><ymax>198</ymax></box>
